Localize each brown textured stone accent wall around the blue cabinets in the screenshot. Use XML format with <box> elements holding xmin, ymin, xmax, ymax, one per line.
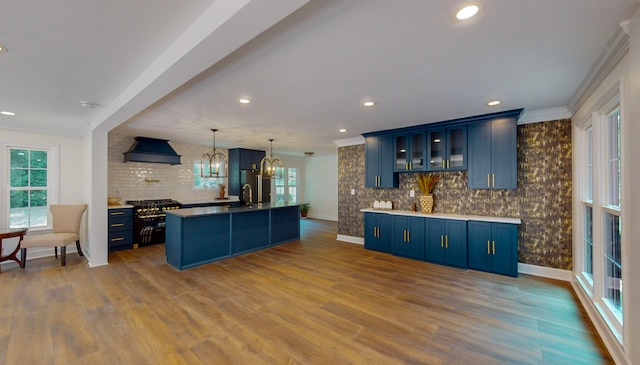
<box><xmin>338</xmin><ymin>119</ymin><xmax>572</xmax><ymax>270</ymax></box>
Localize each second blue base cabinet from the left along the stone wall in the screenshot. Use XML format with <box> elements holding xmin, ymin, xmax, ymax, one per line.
<box><xmin>392</xmin><ymin>216</ymin><xmax>425</xmax><ymax>260</ymax></box>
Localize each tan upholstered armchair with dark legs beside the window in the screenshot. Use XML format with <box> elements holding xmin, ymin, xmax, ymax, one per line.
<box><xmin>20</xmin><ymin>204</ymin><xmax>87</xmax><ymax>268</ymax></box>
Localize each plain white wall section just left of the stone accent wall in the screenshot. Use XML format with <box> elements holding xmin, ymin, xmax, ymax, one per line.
<box><xmin>304</xmin><ymin>154</ymin><xmax>338</xmax><ymax>221</ymax></box>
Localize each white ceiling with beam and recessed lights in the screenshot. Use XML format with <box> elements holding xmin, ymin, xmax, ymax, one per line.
<box><xmin>0</xmin><ymin>0</ymin><xmax>638</xmax><ymax>156</ymax></box>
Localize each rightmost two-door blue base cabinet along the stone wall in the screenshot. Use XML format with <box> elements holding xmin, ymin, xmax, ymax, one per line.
<box><xmin>468</xmin><ymin>221</ymin><xmax>518</xmax><ymax>276</ymax></box>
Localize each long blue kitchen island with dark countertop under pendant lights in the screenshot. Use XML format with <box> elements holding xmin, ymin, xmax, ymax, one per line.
<box><xmin>165</xmin><ymin>203</ymin><xmax>302</xmax><ymax>270</ymax></box>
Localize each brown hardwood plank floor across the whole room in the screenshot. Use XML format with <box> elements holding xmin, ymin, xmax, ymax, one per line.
<box><xmin>0</xmin><ymin>219</ymin><xmax>612</xmax><ymax>365</ymax></box>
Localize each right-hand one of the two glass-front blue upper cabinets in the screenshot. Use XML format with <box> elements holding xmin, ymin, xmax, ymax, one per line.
<box><xmin>427</xmin><ymin>125</ymin><xmax>467</xmax><ymax>171</ymax></box>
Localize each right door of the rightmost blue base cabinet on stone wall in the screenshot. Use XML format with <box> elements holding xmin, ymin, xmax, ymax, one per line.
<box><xmin>491</xmin><ymin>223</ymin><xmax>518</xmax><ymax>276</ymax></box>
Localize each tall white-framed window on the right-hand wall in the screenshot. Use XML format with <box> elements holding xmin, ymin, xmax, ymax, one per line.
<box><xmin>575</xmin><ymin>91</ymin><xmax>628</xmax><ymax>343</ymax></box>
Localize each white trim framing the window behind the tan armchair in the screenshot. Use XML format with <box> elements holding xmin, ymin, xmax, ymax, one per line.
<box><xmin>0</xmin><ymin>142</ymin><xmax>60</xmax><ymax>232</ymax></box>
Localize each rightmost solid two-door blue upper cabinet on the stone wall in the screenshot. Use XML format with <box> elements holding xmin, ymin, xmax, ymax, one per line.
<box><xmin>468</xmin><ymin>118</ymin><xmax>518</xmax><ymax>189</ymax></box>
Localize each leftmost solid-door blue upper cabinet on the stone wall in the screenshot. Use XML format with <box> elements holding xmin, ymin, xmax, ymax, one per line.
<box><xmin>364</xmin><ymin>135</ymin><xmax>399</xmax><ymax>188</ymax></box>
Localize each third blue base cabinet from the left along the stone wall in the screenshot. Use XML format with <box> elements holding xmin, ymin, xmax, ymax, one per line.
<box><xmin>427</xmin><ymin>218</ymin><xmax>467</xmax><ymax>268</ymax></box>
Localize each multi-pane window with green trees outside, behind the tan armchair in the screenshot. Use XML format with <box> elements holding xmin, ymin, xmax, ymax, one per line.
<box><xmin>6</xmin><ymin>146</ymin><xmax>54</xmax><ymax>229</ymax></box>
